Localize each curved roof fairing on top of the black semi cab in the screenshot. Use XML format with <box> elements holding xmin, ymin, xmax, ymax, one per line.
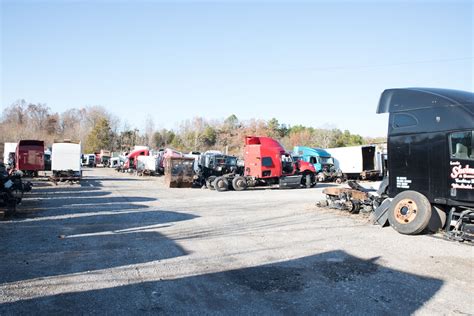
<box><xmin>377</xmin><ymin>88</ymin><xmax>474</xmax><ymax>114</ymax></box>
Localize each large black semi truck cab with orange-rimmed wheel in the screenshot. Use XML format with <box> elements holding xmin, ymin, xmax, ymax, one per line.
<box><xmin>377</xmin><ymin>88</ymin><xmax>474</xmax><ymax>240</ymax></box>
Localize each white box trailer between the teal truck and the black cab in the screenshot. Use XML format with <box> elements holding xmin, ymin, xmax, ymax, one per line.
<box><xmin>325</xmin><ymin>144</ymin><xmax>386</xmax><ymax>180</ymax></box>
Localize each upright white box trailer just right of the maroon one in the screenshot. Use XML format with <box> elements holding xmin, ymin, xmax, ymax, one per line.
<box><xmin>51</xmin><ymin>143</ymin><xmax>82</xmax><ymax>180</ymax></box>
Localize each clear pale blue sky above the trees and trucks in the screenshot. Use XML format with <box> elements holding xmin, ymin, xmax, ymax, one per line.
<box><xmin>1</xmin><ymin>1</ymin><xmax>474</xmax><ymax>136</ymax></box>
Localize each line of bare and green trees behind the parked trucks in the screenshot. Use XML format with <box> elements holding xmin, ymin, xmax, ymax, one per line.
<box><xmin>0</xmin><ymin>100</ymin><xmax>385</xmax><ymax>155</ymax></box>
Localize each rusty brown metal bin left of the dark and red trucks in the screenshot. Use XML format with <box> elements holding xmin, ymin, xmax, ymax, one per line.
<box><xmin>165</xmin><ymin>157</ymin><xmax>194</xmax><ymax>188</ymax></box>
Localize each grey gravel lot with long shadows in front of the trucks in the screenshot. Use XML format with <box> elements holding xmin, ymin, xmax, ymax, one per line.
<box><xmin>0</xmin><ymin>168</ymin><xmax>474</xmax><ymax>315</ymax></box>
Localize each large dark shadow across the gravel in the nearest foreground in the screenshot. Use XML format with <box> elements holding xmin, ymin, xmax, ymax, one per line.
<box><xmin>0</xmin><ymin>251</ymin><xmax>443</xmax><ymax>315</ymax></box>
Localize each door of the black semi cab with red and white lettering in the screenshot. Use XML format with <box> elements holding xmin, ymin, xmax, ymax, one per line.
<box><xmin>448</xmin><ymin>130</ymin><xmax>474</xmax><ymax>202</ymax></box>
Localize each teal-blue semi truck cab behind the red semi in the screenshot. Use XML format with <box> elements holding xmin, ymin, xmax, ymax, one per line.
<box><xmin>293</xmin><ymin>146</ymin><xmax>344</xmax><ymax>183</ymax></box>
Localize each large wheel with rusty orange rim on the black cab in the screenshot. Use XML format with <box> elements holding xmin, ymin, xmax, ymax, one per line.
<box><xmin>388</xmin><ymin>191</ymin><xmax>431</xmax><ymax>235</ymax></box>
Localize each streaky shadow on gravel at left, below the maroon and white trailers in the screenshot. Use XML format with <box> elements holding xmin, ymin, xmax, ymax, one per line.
<box><xmin>0</xmin><ymin>175</ymin><xmax>196</xmax><ymax>283</ymax></box>
